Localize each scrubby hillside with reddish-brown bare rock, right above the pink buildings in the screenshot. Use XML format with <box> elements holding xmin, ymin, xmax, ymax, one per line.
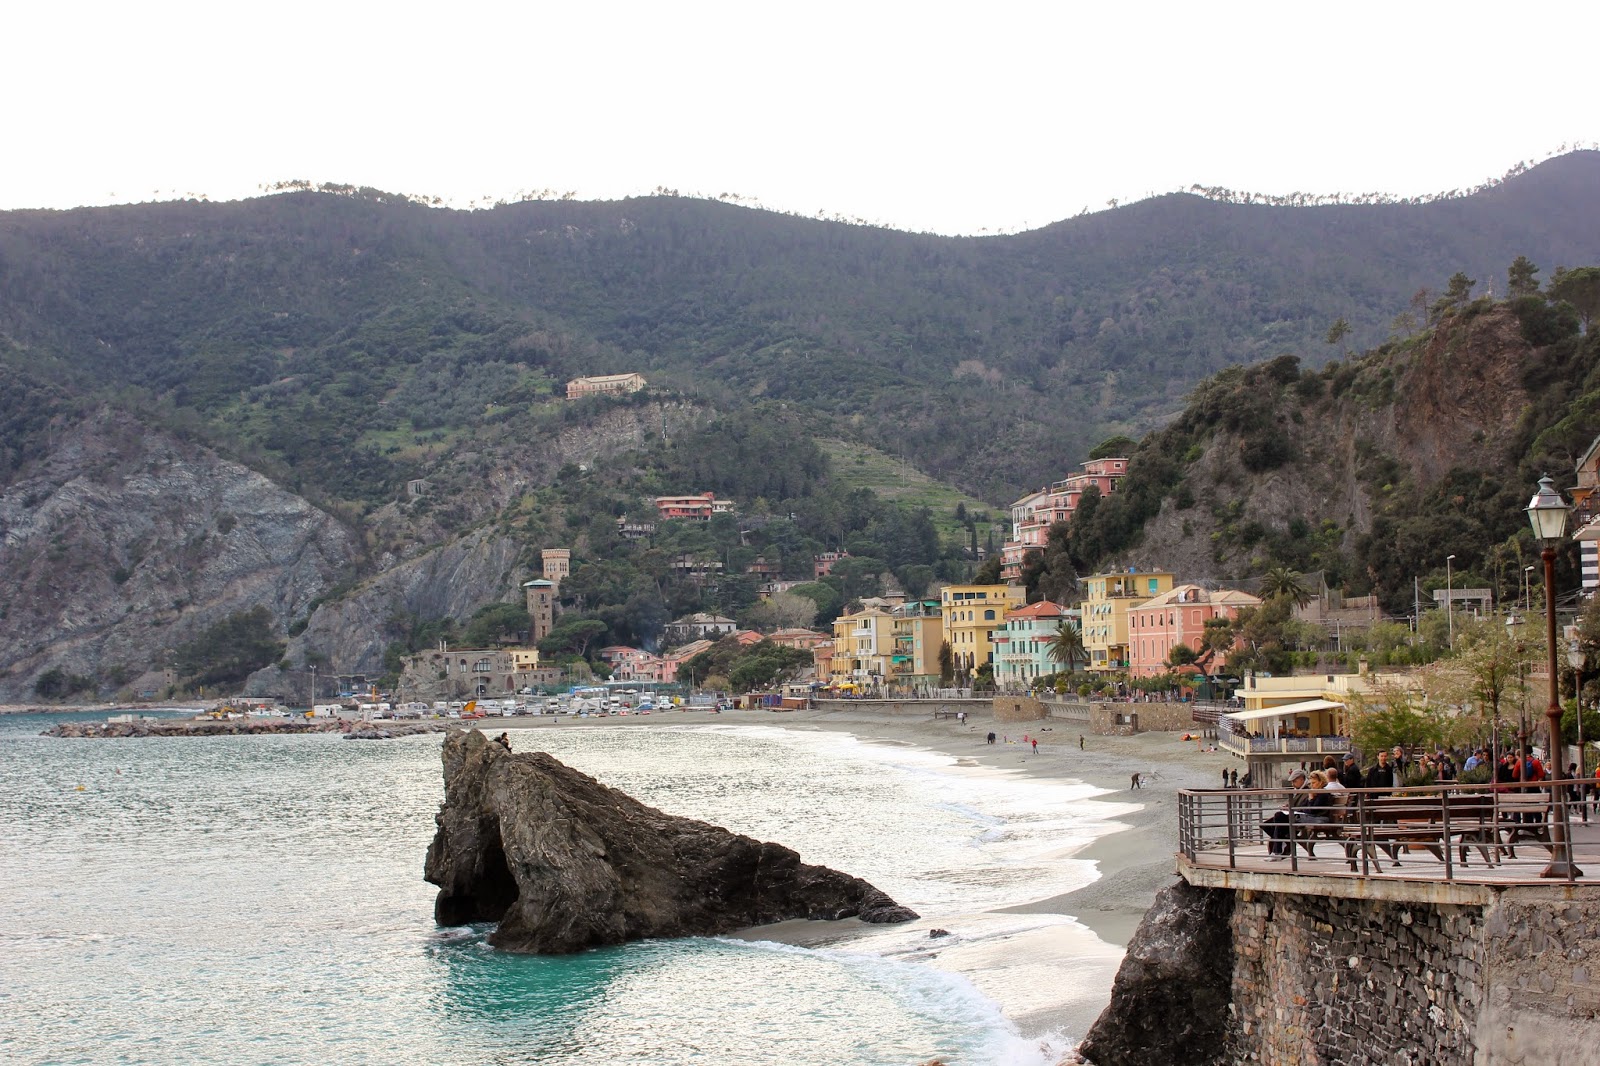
<box><xmin>1027</xmin><ymin>275</ymin><xmax>1600</xmax><ymax>616</ymax></box>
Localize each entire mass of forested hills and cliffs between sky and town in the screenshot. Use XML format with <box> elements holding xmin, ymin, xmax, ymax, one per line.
<box><xmin>0</xmin><ymin>152</ymin><xmax>1600</xmax><ymax>698</ymax></box>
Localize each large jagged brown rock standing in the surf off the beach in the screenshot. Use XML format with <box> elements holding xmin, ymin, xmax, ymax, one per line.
<box><xmin>424</xmin><ymin>731</ymin><xmax>917</xmax><ymax>954</ymax></box>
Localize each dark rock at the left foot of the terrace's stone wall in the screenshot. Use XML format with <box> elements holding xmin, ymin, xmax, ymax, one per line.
<box><xmin>1077</xmin><ymin>880</ymin><xmax>1234</xmax><ymax>1066</ymax></box>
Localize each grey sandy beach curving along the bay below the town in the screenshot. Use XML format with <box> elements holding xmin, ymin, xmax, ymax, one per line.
<box><xmin>477</xmin><ymin>709</ymin><xmax>1238</xmax><ymax>1039</ymax></box>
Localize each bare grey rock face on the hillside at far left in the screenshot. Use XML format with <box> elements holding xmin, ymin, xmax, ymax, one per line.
<box><xmin>0</xmin><ymin>410</ymin><xmax>360</xmax><ymax>699</ymax></box>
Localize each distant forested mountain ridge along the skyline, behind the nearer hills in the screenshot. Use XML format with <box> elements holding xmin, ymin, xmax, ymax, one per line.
<box><xmin>9</xmin><ymin>152</ymin><xmax>1600</xmax><ymax>501</ymax></box>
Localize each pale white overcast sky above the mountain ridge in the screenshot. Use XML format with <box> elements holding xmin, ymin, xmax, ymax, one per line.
<box><xmin>0</xmin><ymin>0</ymin><xmax>1600</xmax><ymax>234</ymax></box>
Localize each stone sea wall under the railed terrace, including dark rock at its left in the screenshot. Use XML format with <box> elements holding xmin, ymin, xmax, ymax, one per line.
<box><xmin>1080</xmin><ymin>879</ymin><xmax>1600</xmax><ymax>1066</ymax></box>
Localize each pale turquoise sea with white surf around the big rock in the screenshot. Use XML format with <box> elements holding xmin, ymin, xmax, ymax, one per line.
<box><xmin>0</xmin><ymin>714</ymin><xmax>1120</xmax><ymax>1066</ymax></box>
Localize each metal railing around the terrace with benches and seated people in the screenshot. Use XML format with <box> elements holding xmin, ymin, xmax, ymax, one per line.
<box><xmin>1178</xmin><ymin>781</ymin><xmax>1600</xmax><ymax>884</ymax></box>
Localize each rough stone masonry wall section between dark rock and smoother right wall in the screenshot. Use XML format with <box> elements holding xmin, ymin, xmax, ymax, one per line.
<box><xmin>1227</xmin><ymin>890</ymin><xmax>1485</xmax><ymax>1066</ymax></box>
